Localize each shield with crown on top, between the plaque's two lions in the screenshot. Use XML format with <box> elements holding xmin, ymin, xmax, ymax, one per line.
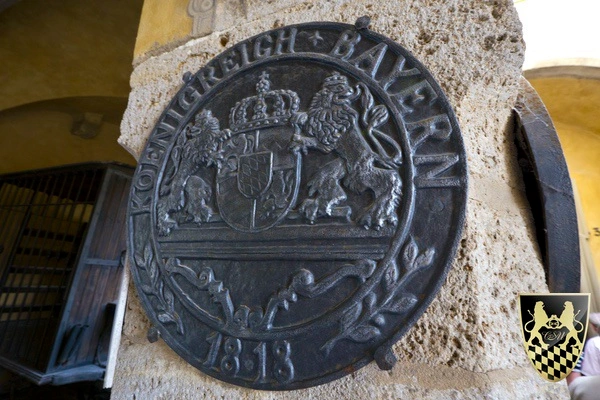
<box><xmin>216</xmin><ymin>74</ymin><xmax>301</xmax><ymax>232</ymax></box>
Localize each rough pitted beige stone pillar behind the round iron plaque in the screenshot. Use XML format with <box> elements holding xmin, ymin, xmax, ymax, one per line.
<box><xmin>113</xmin><ymin>0</ymin><xmax>568</xmax><ymax>399</ymax></box>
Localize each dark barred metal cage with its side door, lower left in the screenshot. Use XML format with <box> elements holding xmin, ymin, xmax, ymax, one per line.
<box><xmin>0</xmin><ymin>163</ymin><xmax>133</xmax><ymax>384</ymax></box>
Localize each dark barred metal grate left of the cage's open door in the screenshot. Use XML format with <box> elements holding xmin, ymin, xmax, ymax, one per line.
<box><xmin>0</xmin><ymin>168</ymin><xmax>104</xmax><ymax>369</ymax></box>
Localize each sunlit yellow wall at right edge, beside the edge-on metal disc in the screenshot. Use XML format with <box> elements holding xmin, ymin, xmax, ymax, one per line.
<box><xmin>530</xmin><ymin>77</ymin><xmax>600</xmax><ymax>274</ymax></box>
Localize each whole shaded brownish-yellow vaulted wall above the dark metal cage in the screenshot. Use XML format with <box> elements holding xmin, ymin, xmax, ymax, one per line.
<box><xmin>0</xmin><ymin>0</ymin><xmax>143</xmax><ymax>174</ymax></box>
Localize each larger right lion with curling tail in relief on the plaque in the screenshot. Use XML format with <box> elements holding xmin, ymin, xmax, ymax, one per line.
<box><xmin>291</xmin><ymin>72</ymin><xmax>402</xmax><ymax>229</ymax></box>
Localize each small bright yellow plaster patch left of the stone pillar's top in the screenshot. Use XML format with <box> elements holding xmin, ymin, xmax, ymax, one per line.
<box><xmin>134</xmin><ymin>0</ymin><xmax>193</xmax><ymax>59</ymax></box>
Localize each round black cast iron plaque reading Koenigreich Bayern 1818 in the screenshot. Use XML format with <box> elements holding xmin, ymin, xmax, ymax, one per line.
<box><xmin>129</xmin><ymin>18</ymin><xmax>467</xmax><ymax>390</ymax></box>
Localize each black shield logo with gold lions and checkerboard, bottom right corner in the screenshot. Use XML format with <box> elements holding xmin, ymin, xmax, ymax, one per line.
<box><xmin>519</xmin><ymin>293</ymin><xmax>589</xmax><ymax>382</ymax></box>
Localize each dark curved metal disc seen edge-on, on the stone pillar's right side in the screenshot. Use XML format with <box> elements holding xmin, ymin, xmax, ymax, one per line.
<box><xmin>515</xmin><ymin>78</ymin><xmax>581</xmax><ymax>293</ymax></box>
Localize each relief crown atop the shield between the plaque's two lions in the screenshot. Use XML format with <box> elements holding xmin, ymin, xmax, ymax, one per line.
<box><xmin>229</xmin><ymin>71</ymin><xmax>300</xmax><ymax>133</ymax></box>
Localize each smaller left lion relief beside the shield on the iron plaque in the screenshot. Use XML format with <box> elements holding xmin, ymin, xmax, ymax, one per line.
<box><xmin>157</xmin><ymin>110</ymin><xmax>229</xmax><ymax>236</ymax></box>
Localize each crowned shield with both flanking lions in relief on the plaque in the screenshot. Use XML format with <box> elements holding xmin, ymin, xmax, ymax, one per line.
<box><xmin>157</xmin><ymin>71</ymin><xmax>402</xmax><ymax>236</ymax></box>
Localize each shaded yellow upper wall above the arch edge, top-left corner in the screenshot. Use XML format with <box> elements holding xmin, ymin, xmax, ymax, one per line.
<box><xmin>0</xmin><ymin>0</ymin><xmax>143</xmax><ymax>110</ymax></box>
